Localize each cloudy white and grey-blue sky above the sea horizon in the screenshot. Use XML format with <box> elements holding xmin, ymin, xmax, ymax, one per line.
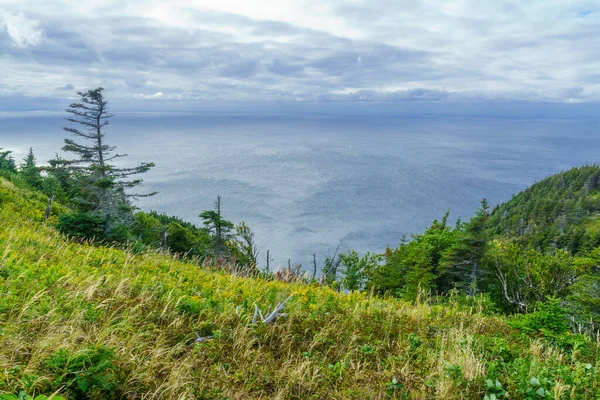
<box><xmin>0</xmin><ymin>0</ymin><xmax>600</xmax><ymax>115</ymax></box>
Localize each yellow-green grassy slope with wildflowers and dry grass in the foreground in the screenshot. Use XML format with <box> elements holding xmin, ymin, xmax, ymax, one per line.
<box><xmin>0</xmin><ymin>181</ymin><xmax>600</xmax><ymax>399</ymax></box>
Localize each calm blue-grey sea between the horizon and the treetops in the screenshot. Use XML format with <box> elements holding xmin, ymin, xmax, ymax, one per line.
<box><xmin>0</xmin><ymin>114</ymin><xmax>600</xmax><ymax>266</ymax></box>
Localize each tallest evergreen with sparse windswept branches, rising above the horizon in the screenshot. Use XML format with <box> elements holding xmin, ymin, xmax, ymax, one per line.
<box><xmin>61</xmin><ymin>87</ymin><xmax>155</xmax><ymax>234</ymax></box>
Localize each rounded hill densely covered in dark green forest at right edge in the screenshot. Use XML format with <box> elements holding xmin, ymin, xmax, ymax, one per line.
<box><xmin>488</xmin><ymin>165</ymin><xmax>600</xmax><ymax>253</ymax></box>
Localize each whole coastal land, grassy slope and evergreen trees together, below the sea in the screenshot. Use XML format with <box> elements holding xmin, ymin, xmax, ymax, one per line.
<box><xmin>0</xmin><ymin>88</ymin><xmax>600</xmax><ymax>399</ymax></box>
